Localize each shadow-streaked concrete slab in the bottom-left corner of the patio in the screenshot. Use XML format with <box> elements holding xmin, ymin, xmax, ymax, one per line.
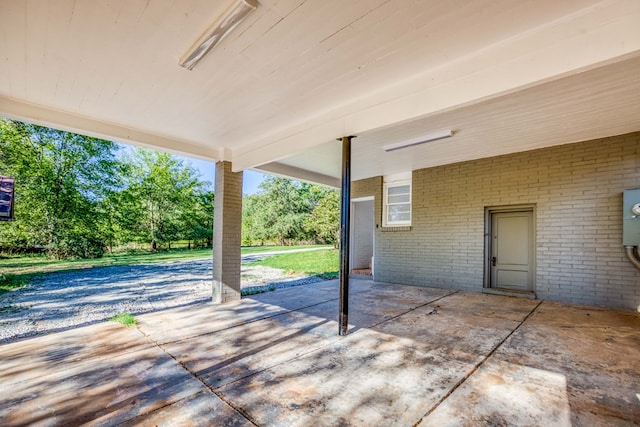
<box><xmin>0</xmin><ymin>323</ymin><xmax>244</xmax><ymax>426</ymax></box>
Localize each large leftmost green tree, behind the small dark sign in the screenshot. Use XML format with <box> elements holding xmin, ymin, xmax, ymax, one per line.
<box><xmin>0</xmin><ymin>120</ymin><xmax>121</xmax><ymax>258</ymax></box>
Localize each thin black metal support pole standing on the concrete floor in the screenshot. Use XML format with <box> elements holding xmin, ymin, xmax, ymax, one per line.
<box><xmin>338</xmin><ymin>136</ymin><xmax>355</xmax><ymax>336</ymax></box>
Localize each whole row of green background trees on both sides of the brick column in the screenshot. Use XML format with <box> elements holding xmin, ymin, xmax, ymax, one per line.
<box><xmin>0</xmin><ymin>119</ymin><xmax>338</xmax><ymax>258</ymax></box>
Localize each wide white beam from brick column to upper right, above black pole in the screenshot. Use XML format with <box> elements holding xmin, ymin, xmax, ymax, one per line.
<box><xmin>232</xmin><ymin>0</ymin><xmax>640</xmax><ymax>171</ymax></box>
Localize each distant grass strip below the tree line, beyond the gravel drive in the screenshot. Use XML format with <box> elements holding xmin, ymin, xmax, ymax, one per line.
<box><xmin>0</xmin><ymin>245</ymin><xmax>337</xmax><ymax>294</ymax></box>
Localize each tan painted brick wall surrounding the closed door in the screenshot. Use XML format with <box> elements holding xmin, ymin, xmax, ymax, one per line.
<box><xmin>352</xmin><ymin>133</ymin><xmax>640</xmax><ymax>308</ymax></box>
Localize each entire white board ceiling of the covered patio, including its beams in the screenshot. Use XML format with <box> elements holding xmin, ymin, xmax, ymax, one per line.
<box><xmin>0</xmin><ymin>0</ymin><xmax>640</xmax><ymax>185</ymax></box>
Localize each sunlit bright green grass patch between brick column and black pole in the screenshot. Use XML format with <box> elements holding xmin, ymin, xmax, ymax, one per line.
<box><xmin>247</xmin><ymin>249</ymin><xmax>338</xmax><ymax>279</ymax></box>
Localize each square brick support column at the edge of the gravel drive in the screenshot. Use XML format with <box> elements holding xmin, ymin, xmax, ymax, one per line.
<box><xmin>212</xmin><ymin>162</ymin><xmax>242</xmax><ymax>303</ymax></box>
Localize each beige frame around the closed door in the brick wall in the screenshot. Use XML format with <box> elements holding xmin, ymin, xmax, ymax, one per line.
<box><xmin>482</xmin><ymin>203</ymin><xmax>538</xmax><ymax>294</ymax></box>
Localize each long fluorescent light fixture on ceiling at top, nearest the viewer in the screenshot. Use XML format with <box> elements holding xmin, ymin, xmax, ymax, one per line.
<box><xmin>178</xmin><ymin>0</ymin><xmax>258</xmax><ymax>70</ymax></box>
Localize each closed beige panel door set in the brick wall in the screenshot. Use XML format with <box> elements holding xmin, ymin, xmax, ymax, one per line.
<box><xmin>489</xmin><ymin>210</ymin><xmax>534</xmax><ymax>291</ymax></box>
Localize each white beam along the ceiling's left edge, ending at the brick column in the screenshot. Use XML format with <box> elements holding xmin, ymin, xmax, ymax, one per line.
<box><xmin>0</xmin><ymin>96</ymin><xmax>222</xmax><ymax>161</ymax></box>
